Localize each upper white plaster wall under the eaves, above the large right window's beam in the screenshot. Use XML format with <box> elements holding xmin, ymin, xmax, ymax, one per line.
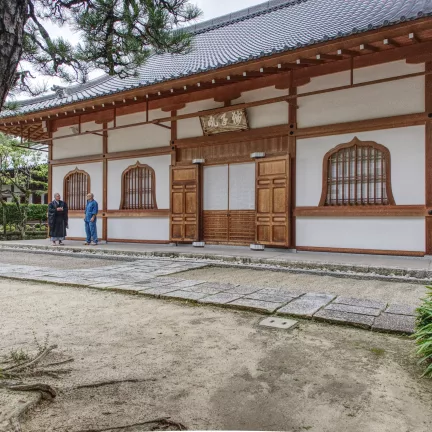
<box><xmin>298</xmin><ymin>61</ymin><xmax>425</xmax><ymax>127</ymax></box>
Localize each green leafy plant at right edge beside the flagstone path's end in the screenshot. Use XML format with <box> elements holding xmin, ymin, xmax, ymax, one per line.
<box><xmin>414</xmin><ymin>286</ymin><xmax>432</xmax><ymax>378</ymax></box>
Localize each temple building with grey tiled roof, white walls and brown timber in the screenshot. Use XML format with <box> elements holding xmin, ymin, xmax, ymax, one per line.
<box><xmin>0</xmin><ymin>0</ymin><xmax>432</xmax><ymax>256</ymax></box>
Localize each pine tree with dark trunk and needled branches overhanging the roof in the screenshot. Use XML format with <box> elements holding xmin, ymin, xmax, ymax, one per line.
<box><xmin>0</xmin><ymin>0</ymin><xmax>200</xmax><ymax>110</ymax></box>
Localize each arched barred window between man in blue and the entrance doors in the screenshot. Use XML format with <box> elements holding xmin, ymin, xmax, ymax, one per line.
<box><xmin>120</xmin><ymin>162</ymin><xmax>157</xmax><ymax>210</ymax></box>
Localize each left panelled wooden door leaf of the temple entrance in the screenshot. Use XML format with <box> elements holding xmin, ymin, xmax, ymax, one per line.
<box><xmin>170</xmin><ymin>165</ymin><xmax>199</xmax><ymax>242</ymax></box>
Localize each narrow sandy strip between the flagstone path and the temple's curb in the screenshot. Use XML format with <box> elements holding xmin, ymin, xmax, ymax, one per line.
<box><xmin>181</xmin><ymin>267</ymin><xmax>426</xmax><ymax>306</ymax></box>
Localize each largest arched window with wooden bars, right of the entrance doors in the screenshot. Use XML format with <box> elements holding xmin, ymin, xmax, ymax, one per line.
<box><xmin>319</xmin><ymin>137</ymin><xmax>395</xmax><ymax>206</ymax></box>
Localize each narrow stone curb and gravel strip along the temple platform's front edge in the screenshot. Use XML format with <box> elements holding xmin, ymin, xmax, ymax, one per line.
<box><xmin>0</xmin><ymin>245</ymin><xmax>432</xmax><ymax>285</ymax></box>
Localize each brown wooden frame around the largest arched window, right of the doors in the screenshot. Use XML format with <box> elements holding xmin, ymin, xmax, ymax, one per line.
<box><xmin>319</xmin><ymin>137</ymin><xmax>396</xmax><ymax>208</ymax></box>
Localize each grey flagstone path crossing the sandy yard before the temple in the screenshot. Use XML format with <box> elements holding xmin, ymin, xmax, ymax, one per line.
<box><xmin>0</xmin><ymin>259</ymin><xmax>415</xmax><ymax>334</ymax></box>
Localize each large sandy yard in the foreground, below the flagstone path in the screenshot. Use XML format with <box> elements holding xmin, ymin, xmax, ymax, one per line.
<box><xmin>0</xmin><ymin>272</ymin><xmax>432</xmax><ymax>432</ymax></box>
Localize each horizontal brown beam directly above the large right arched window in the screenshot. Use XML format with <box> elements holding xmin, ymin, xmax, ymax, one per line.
<box><xmin>294</xmin><ymin>112</ymin><xmax>428</xmax><ymax>139</ymax></box>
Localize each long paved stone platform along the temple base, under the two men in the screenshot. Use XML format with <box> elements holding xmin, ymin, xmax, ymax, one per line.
<box><xmin>0</xmin><ymin>240</ymin><xmax>432</xmax><ymax>284</ymax></box>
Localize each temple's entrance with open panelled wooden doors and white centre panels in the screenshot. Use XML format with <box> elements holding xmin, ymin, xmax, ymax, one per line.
<box><xmin>170</xmin><ymin>156</ymin><xmax>290</xmax><ymax>247</ymax></box>
